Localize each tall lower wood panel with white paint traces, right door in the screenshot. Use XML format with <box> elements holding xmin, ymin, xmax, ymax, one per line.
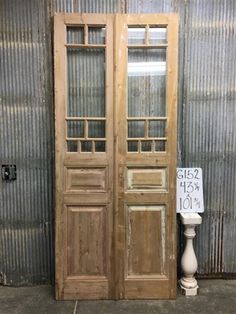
<box><xmin>127</xmin><ymin>205</ymin><xmax>166</xmax><ymax>277</ymax></box>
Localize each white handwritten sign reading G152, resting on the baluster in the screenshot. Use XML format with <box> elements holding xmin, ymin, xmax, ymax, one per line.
<box><xmin>176</xmin><ymin>168</ymin><xmax>204</xmax><ymax>213</ymax></box>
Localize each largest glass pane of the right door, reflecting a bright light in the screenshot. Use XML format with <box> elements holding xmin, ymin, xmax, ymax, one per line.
<box><xmin>128</xmin><ymin>48</ymin><xmax>166</xmax><ymax>117</ymax></box>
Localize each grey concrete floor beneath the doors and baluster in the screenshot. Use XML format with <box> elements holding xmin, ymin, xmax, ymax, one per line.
<box><xmin>0</xmin><ymin>280</ymin><xmax>236</xmax><ymax>314</ymax></box>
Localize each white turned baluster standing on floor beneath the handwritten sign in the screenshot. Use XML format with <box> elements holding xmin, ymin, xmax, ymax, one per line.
<box><xmin>180</xmin><ymin>213</ymin><xmax>202</xmax><ymax>296</ymax></box>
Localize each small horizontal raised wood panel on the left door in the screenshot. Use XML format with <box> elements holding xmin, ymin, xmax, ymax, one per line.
<box><xmin>65</xmin><ymin>168</ymin><xmax>107</xmax><ymax>192</ymax></box>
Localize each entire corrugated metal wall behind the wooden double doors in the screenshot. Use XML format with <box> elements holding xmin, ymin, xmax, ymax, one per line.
<box><xmin>0</xmin><ymin>0</ymin><xmax>236</xmax><ymax>285</ymax></box>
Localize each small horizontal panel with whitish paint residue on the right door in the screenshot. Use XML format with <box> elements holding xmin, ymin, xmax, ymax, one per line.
<box><xmin>127</xmin><ymin>168</ymin><xmax>167</xmax><ymax>191</ymax></box>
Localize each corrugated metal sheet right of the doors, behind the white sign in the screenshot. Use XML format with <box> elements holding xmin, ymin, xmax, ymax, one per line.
<box><xmin>183</xmin><ymin>0</ymin><xmax>236</xmax><ymax>274</ymax></box>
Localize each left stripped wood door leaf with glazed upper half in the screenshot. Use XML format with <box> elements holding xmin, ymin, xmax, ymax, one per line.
<box><xmin>54</xmin><ymin>14</ymin><xmax>113</xmax><ymax>300</ymax></box>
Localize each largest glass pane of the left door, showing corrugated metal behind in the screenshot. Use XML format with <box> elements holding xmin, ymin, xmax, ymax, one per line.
<box><xmin>67</xmin><ymin>48</ymin><xmax>105</xmax><ymax>117</ymax></box>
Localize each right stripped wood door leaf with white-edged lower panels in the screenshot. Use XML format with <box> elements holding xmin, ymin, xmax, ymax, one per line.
<box><xmin>115</xmin><ymin>14</ymin><xmax>178</xmax><ymax>299</ymax></box>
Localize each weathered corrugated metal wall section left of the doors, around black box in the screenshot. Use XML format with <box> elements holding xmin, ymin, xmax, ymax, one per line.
<box><xmin>0</xmin><ymin>0</ymin><xmax>54</xmax><ymax>285</ymax></box>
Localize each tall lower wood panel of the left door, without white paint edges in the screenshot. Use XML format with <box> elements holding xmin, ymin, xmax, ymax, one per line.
<box><xmin>67</xmin><ymin>206</ymin><xmax>107</xmax><ymax>277</ymax></box>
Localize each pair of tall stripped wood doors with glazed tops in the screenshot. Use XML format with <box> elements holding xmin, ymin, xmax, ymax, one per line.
<box><xmin>54</xmin><ymin>13</ymin><xmax>178</xmax><ymax>300</ymax></box>
